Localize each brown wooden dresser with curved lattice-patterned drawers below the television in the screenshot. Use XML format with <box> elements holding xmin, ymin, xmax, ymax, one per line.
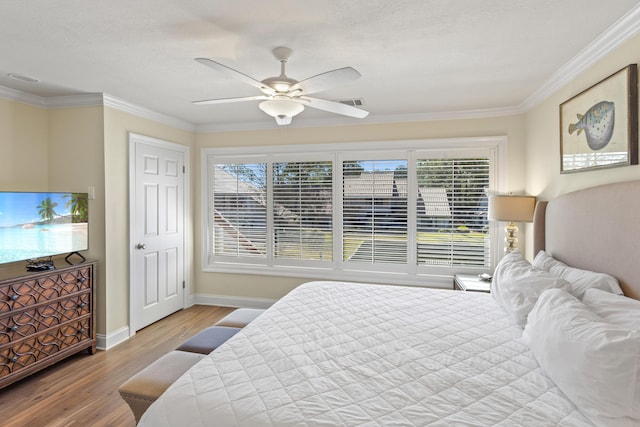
<box><xmin>0</xmin><ymin>262</ymin><xmax>96</xmax><ymax>388</ymax></box>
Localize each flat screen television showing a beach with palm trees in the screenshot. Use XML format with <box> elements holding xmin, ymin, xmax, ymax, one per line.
<box><xmin>0</xmin><ymin>192</ymin><xmax>89</xmax><ymax>263</ymax></box>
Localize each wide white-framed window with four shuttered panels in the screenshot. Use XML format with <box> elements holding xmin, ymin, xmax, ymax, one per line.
<box><xmin>204</xmin><ymin>138</ymin><xmax>504</xmax><ymax>290</ymax></box>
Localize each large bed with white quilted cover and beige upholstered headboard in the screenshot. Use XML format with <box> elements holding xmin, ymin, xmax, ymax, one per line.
<box><xmin>139</xmin><ymin>181</ymin><xmax>640</xmax><ymax>427</ymax></box>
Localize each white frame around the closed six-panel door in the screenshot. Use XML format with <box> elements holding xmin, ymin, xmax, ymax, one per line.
<box><xmin>128</xmin><ymin>132</ymin><xmax>191</xmax><ymax>337</ymax></box>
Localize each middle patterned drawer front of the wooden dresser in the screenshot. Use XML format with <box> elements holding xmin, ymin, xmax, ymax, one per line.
<box><xmin>0</xmin><ymin>291</ymin><xmax>91</xmax><ymax>345</ymax></box>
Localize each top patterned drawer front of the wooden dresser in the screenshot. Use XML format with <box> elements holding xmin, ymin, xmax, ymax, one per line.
<box><xmin>0</xmin><ymin>267</ymin><xmax>91</xmax><ymax>313</ymax></box>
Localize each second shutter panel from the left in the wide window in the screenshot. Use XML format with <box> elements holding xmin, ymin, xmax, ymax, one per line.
<box><xmin>273</xmin><ymin>161</ymin><xmax>333</xmax><ymax>261</ymax></box>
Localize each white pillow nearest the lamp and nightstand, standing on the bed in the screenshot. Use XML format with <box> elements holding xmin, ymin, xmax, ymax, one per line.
<box><xmin>491</xmin><ymin>249</ymin><xmax>570</xmax><ymax>326</ymax></box>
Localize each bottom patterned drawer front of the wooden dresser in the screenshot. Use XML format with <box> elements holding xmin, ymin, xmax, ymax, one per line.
<box><xmin>0</xmin><ymin>317</ymin><xmax>91</xmax><ymax>376</ymax></box>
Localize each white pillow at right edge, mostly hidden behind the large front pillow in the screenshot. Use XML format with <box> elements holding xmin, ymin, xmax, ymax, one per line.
<box><xmin>582</xmin><ymin>289</ymin><xmax>640</xmax><ymax>331</ymax></box>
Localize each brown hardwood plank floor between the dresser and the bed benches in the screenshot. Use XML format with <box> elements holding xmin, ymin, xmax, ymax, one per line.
<box><xmin>0</xmin><ymin>305</ymin><xmax>233</xmax><ymax>427</ymax></box>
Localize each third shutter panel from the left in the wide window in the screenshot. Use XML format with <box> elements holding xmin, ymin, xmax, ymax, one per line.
<box><xmin>342</xmin><ymin>160</ymin><xmax>407</xmax><ymax>264</ymax></box>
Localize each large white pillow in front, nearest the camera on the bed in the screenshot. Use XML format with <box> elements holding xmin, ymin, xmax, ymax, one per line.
<box><xmin>525</xmin><ymin>289</ymin><xmax>640</xmax><ymax>426</ymax></box>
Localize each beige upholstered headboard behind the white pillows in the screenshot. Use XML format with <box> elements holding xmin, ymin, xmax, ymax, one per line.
<box><xmin>534</xmin><ymin>181</ymin><xmax>640</xmax><ymax>299</ymax></box>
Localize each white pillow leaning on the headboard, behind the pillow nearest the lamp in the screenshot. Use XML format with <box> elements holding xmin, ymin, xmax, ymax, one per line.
<box><xmin>533</xmin><ymin>251</ymin><xmax>622</xmax><ymax>299</ymax></box>
